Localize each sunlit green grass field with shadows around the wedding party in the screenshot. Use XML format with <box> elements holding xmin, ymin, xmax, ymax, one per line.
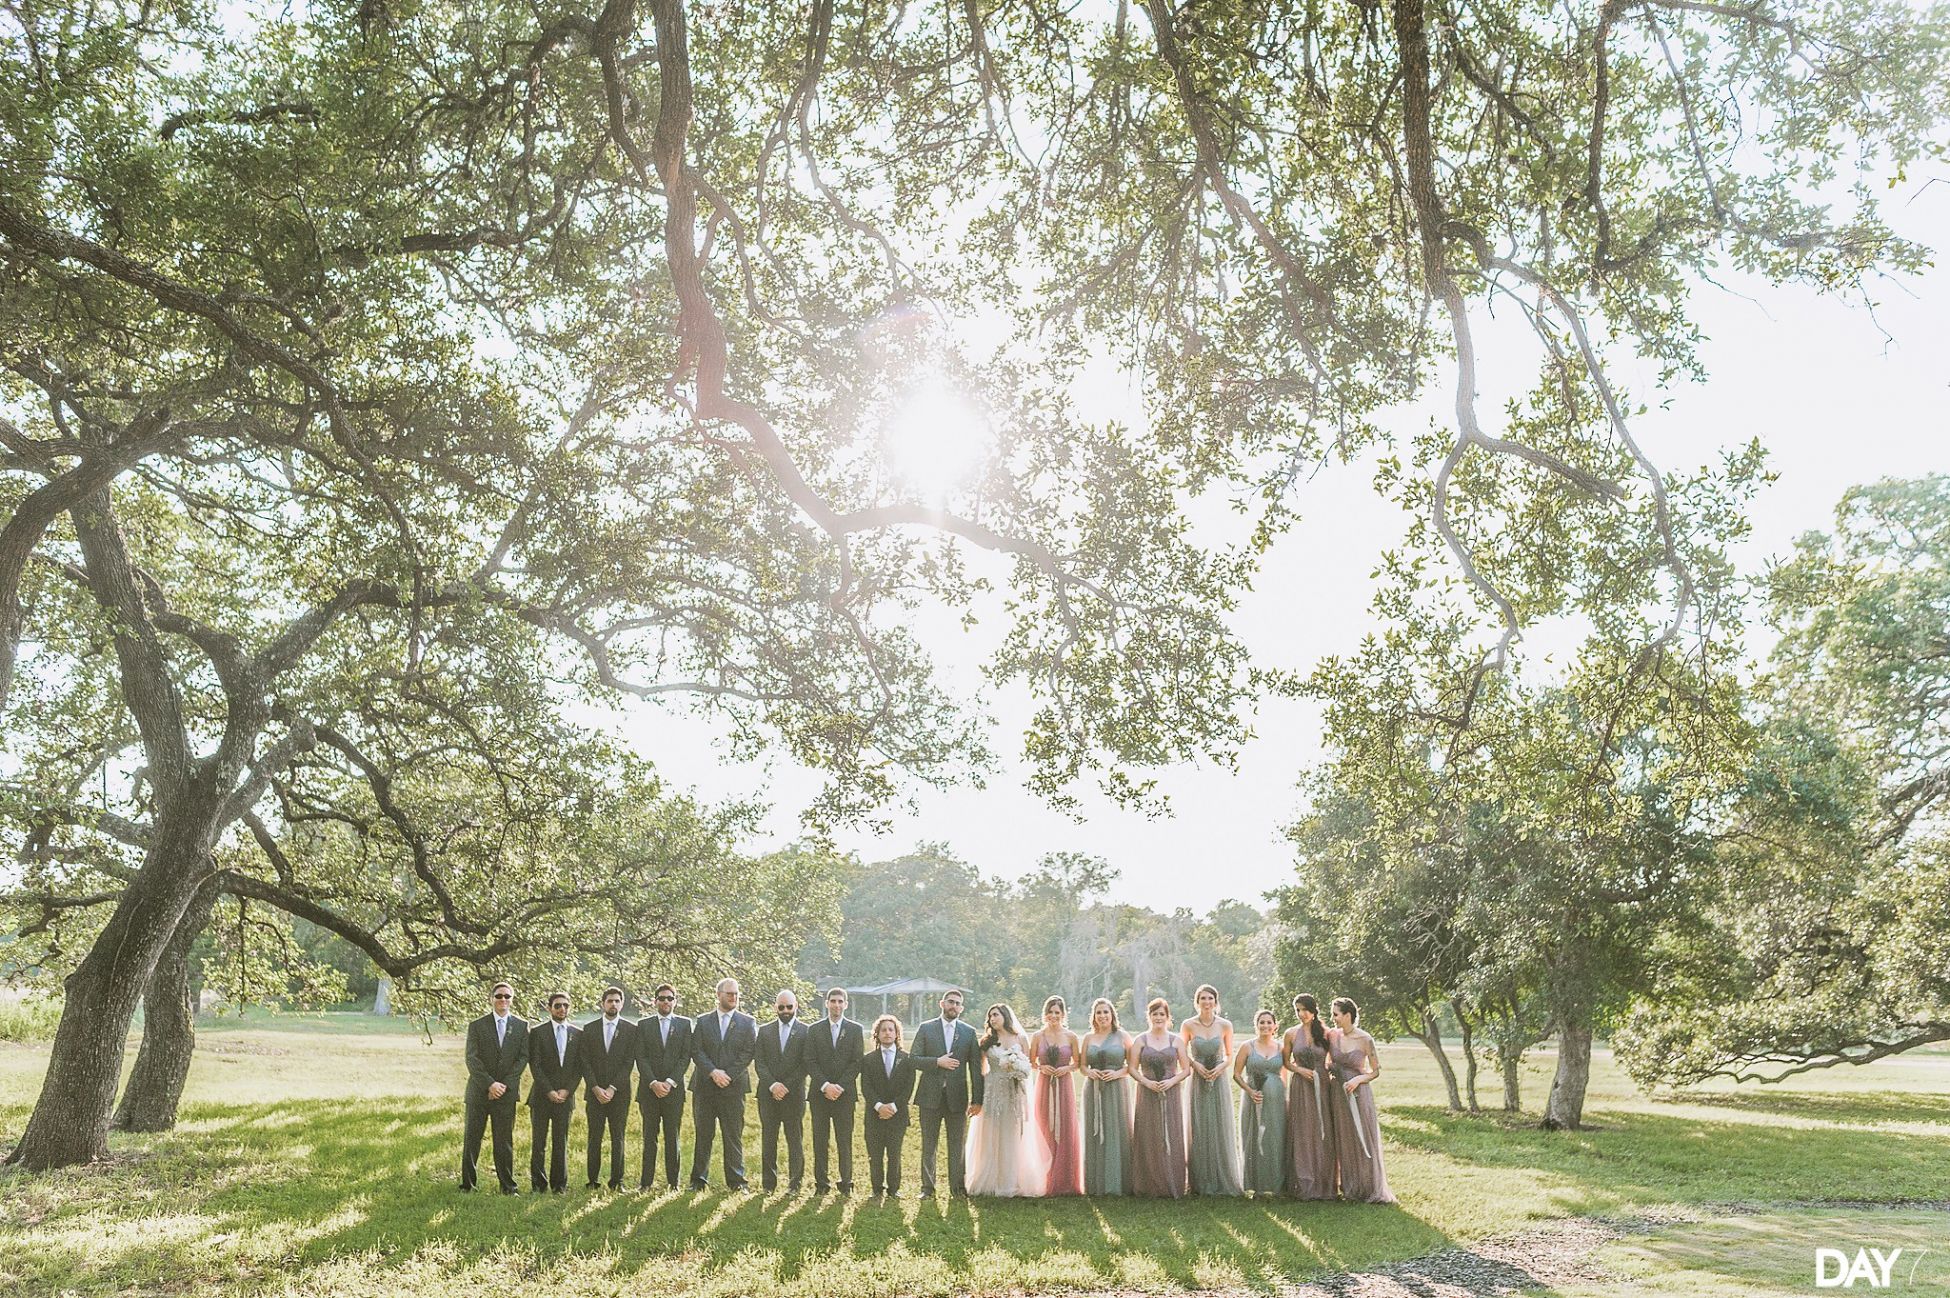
<box><xmin>0</xmin><ymin>1015</ymin><xmax>1950</xmax><ymax>1298</ymax></box>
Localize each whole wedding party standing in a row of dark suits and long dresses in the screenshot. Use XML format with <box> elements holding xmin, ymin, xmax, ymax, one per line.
<box><xmin>460</xmin><ymin>978</ymin><xmax>1394</xmax><ymax>1203</ymax></box>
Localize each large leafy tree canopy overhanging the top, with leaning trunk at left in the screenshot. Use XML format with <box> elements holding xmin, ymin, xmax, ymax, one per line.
<box><xmin>0</xmin><ymin>0</ymin><xmax>1950</xmax><ymax>1165</ymax></box>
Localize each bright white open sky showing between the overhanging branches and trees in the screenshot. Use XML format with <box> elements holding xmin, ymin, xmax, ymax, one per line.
<box><xmin>628</xmin><ymin>183</ymin><xmax>1950</xmax><ymax>910</ymax></box>
